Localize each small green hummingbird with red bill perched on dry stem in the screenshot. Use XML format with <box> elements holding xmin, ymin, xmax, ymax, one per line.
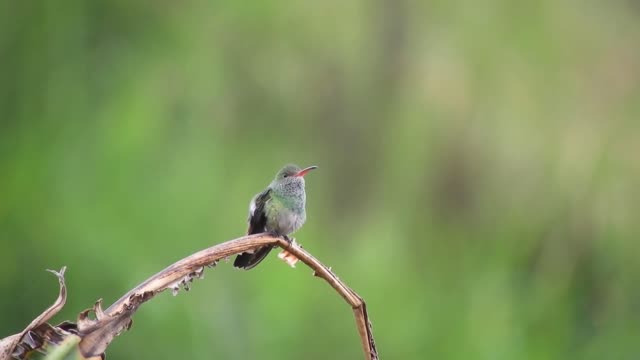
<box><xmin>233</xmin><ymin>164</ymin><xmax>318</xmax><ymax>270</ymax></box>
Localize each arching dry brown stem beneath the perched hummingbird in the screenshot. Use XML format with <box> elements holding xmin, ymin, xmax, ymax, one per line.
<box><xmin>1</xmin><ymin>233</ymin><xmax>378</xmax><ymax>360</ymax></box>
